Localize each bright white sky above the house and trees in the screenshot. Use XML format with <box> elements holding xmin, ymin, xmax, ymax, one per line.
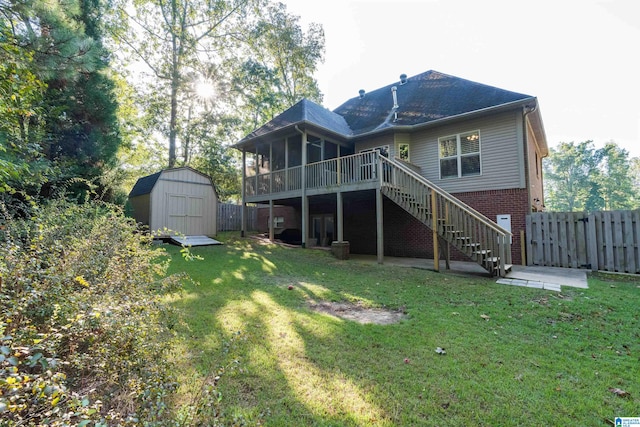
<box><xmin>280</xmin><ymin>0</ymin><xmax>640</xmax><ymax>157</ymax></box>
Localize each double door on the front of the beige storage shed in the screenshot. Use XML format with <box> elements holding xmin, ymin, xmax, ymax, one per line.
<box><xmin>167</xmin><ymin>194</ymin><xmax>204</xmax><ymax>236</ymax></box>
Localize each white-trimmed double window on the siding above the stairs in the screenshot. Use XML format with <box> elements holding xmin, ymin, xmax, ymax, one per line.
<box><xmin>438</xmin><ymin>130</ymin><xmax>481</xmax><ymax>179</ymax></box>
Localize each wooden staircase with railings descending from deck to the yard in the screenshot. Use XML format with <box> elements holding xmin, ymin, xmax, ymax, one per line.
<box><xmin>378</xmin><ymin>156</ymin><xmax>511</xmax><ymax>277</ymax></box>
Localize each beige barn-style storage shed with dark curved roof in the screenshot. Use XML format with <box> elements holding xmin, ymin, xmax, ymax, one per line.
<box><xmin>129</xmin><ymin>166</ymin><xmax>218</xmax><ymax>237</ymax></box>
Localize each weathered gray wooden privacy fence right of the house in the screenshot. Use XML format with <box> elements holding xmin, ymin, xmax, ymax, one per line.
<box><xmin>526</xmin><ymin>209</ymin><xmax>640</xmax><ymax>274</ymax></box>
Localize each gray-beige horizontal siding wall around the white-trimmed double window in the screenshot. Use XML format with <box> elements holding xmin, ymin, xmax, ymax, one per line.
<box><xmin>410</xmin><ymin>111</ymin><xmax>525</xmax><ymax>193</ymax></box>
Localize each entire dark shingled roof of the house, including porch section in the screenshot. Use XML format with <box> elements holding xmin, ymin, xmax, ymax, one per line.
<box><xmin>237</xmin><ymin>70</ymin><xmax>535</xmax><ymax>146</ymax></box>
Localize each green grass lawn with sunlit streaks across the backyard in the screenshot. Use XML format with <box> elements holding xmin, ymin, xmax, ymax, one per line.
<box><xmin>169</xmin><ymin>234</ymin><xmax>640</xmax><ymax>427</ymax></box>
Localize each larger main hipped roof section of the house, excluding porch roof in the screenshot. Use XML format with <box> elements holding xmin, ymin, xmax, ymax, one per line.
<box><xmin>334</xmin><ymin>70</ymin><xmax>532</xmax><ymax>135</ymax></box>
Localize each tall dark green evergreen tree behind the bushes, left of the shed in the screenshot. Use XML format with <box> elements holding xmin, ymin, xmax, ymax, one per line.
<box><xmin>42</xmin><ymin>0</ymin><xmax>121</xmax><ymax>199</ymax></box>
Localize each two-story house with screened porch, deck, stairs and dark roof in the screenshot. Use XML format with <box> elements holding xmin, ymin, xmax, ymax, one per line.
<box><xmin>235</xmin><ymin>71</ymin><xmax>548</xmax><ymax>275</ymax></box>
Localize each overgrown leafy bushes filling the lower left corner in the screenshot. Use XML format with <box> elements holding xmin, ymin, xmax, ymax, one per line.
<box><xmin>0</xmin><ymin>201</ymin><xmax>185</xmax><ymax>426</ymax></box>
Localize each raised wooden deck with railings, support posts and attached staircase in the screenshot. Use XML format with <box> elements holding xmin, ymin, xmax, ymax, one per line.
<box><xmin>244</xmin><ymin>151</ymin><xmax>512</xmax><ymax>277</ymax></box>
